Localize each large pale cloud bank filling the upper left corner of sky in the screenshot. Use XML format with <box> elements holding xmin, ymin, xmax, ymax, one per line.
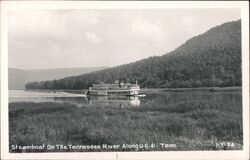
<box><xmin>9</xmin><ymin>10</ymin><xmax>100</xmax><ymax>42</ymax></box>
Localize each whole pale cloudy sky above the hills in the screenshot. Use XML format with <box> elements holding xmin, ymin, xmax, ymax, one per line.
<box><xmin>8</xmin><ymin>8</ymin><xmax>240</xmax><ymax>69</ymax></box>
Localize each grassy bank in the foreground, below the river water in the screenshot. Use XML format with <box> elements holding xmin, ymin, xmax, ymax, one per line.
<box><xmin>9</xmin><ymin>98</ymin><xmax>243</xmax><ymax>152</ymax></box>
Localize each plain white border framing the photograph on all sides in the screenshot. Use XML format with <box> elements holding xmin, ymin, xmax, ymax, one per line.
<box><xmin>0</xmin><ymin>1</ymin><xmax>249</xmax><ymax>160</ymax></box>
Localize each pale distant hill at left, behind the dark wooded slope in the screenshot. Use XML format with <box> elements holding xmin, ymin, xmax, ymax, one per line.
<box><xmin>8</xmin><ymin>67</ymin><xmax>107</xmax><ymax>89</ymax></box>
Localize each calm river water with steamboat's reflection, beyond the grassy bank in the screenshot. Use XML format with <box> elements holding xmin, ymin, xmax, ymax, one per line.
<box><xmin>9</xmin><ymin>91</ymin><xmax>242</xmax><ymax>107</ymax></box>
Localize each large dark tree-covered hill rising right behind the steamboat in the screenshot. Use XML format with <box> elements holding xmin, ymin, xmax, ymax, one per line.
<box><xmin>26</xmin><ymin>20</ymin><xmax>241</xmax><ymax>89</ymax></box>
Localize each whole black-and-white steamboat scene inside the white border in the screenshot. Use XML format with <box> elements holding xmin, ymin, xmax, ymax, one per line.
<box><xmin>1</xmin><ymin>2</ymin><xmax>249</xmax><ymax>159</ymax></box>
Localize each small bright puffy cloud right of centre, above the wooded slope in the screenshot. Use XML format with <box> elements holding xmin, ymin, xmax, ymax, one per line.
<box><xmin>131</xmin><ymin>17</ymin><xmax>165</xmax><ymax>40</ymax></box>
